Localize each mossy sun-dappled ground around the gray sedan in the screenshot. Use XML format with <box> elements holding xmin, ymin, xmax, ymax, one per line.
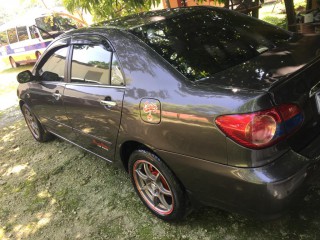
<box><xmin>0</xmin><ymin>66</ymin><xmax>320</xmax><ymax>240</ymax></box>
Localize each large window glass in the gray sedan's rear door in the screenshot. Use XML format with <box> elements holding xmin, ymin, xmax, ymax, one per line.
<box><xmin>71</xmin><ymin>45</ymin><xmax>112</xmax><ymax>85</ymax></box>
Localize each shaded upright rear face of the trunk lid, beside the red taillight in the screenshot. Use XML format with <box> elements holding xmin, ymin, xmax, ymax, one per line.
<box><xmin>269</xmin><ymin>52</ymin><xmax>320</xmax><ymax>152</ymax></box>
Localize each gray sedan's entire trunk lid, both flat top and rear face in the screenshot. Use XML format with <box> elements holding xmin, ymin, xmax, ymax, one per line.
<box><xmin>199</xmin><ymin>33</ymin><xmax>320</xmax><ymax>152</ymax></box>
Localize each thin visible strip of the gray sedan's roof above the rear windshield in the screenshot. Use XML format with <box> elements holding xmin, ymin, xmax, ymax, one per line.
<box><xmin>92</xmin><ymin>6</ymin><xmax>219</xmax><ymax>30</ymax></box>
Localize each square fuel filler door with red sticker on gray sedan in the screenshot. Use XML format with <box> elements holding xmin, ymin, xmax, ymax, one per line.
<box><xmin>140</xmin><ymin>99</ymin><xmax>160</xmax><ymax>123</ymax></box>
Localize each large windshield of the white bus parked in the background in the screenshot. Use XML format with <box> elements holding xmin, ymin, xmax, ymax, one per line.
<box><xmin>36</xmin><ymin>15</ymin><xmax>77</xmax><ymax>39</ymax></box>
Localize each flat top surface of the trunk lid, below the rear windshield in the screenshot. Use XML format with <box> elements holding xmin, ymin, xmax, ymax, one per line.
<box><xmin>197</xmin><ymin>36</ymin><xmax>320</xmax><ymax>91</ymax></box>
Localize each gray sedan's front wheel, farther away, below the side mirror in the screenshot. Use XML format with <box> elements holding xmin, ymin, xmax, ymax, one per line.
<box><xmin>21</xmin><ymin>104</ymin><xmax>53</xmax><ymax>142</ymax></box>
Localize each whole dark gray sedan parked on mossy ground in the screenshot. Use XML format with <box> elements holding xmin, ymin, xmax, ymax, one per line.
<box><xmin>18</xmin><ymin>7</ymin><xmax>320</xmax><ymax>221</ymax></box>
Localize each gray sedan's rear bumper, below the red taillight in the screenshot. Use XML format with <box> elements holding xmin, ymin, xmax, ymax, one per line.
<box><xmin>157</xmin><ymin>151</ymin><xmax>318</xmax><ymax>219</ymax></box>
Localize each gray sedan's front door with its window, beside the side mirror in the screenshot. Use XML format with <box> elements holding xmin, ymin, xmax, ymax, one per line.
<box><xmin>29</xmin><ymin>40</ymin><xmax>75</xmax><ymax>140</ymax></box>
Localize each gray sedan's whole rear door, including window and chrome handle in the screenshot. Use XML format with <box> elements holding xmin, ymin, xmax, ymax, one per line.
<box><xmin>63</xmin><ymin>36</ymin><xmax>125</xmax><ymax>161</ymax></box>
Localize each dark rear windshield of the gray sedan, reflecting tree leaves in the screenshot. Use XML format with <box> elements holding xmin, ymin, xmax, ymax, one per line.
<box><xmin>131</xmin><ymin>8</ymin><xmax>291</xmax><ymax>81</ymax></box>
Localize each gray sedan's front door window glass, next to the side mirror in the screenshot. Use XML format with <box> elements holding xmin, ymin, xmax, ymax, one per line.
<box><xmin>39</xmin><ymin>47</ymin><xmax>68</xmax><ymax>82</ymax></box>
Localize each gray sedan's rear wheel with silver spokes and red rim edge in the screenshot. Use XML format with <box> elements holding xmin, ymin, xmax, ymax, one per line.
<box><xmin>129</xmin><ymin>150</ymin><xmax>187</xmax><ymax>221</ymax></box>
